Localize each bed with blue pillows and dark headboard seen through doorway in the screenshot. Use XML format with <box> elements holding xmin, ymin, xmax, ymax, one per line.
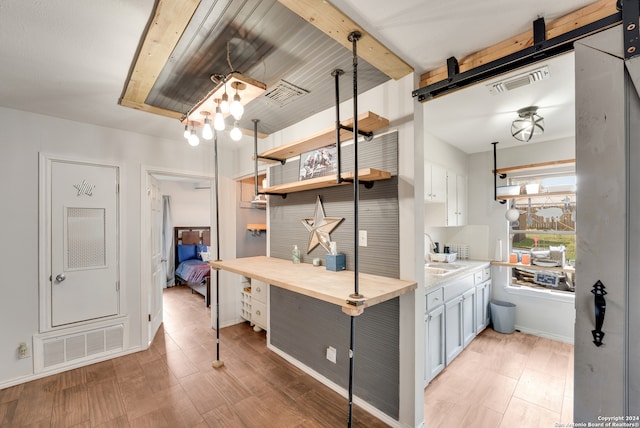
<box><xmin>173</xmin><ymin>226</ymin><xmax>211</xmax><ymax>307</ymax></box>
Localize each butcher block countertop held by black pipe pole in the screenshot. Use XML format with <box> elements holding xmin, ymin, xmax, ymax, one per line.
<box><xmin>209</xmin><ymin>256</ymin><xmax>417</xmax><ymax>316</ymax></box>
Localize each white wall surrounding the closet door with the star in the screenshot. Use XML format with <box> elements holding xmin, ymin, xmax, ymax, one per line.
<box><xmin>0</xmin><ymin>108</ymin><xmax>235</xmax><ymax>388</ymax></box>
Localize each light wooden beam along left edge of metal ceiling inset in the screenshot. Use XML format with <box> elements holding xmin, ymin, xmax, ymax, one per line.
<box><xmin>120</xmin><ymin>0</ymin><xmax>200</xmax><ymax>119</ymax></box>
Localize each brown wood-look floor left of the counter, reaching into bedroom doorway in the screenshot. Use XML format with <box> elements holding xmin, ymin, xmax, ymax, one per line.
<box><xmin>0</xmin><ymin>286</ymin><xmax>386</xmax><ymax>428</ymax></box>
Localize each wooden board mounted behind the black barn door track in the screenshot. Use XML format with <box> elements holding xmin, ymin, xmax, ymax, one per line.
<box><xmin>420</xmin><ymin>0</ymin><xmax>619</xmax><ymax>88</ymax></box>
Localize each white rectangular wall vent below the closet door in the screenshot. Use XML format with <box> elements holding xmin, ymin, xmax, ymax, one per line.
<box><xmin>34</xmin><ymin>324</ymin><xmax>124</xmax><ymax>370</ymax></box>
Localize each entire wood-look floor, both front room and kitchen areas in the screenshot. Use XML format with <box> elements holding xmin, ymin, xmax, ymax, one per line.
<box><xmin>0</xmin><ymin>287</ymin><xmax>573</xmax><ymax>428</ymax></box>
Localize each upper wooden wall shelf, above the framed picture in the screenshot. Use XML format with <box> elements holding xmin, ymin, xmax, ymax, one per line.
<box><xmin>258</xmin><ymin>111</ymin><xmax>389</xmax><ymax>162</ymax></box>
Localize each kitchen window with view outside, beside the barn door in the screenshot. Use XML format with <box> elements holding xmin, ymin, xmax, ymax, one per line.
<box><xmin>508</xmin><ymin>169</ymin><xmax>577</xmax><ymax>293</ymax></box>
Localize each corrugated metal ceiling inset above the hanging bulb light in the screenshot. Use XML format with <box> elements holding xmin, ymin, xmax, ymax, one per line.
<box><xmin>146</xmin><ymin>0</ymin><xmax>389</xmax><ymax>134</ymax></box>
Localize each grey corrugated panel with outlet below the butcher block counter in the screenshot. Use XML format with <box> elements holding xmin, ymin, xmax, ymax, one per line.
<box><xmin>270</xmin><ymin>287</ymin><xmax>400</xmax><ymax>419</ymax></box>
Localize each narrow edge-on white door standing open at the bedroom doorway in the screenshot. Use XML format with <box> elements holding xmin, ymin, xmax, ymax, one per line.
<box><xmin>148</xmin><ymin>175</ymin><xmax>166</xmax><ymax>343</ymax></box>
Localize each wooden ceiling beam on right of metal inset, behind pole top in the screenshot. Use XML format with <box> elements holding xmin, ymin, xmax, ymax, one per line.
<box><xmin>278</xmin><ymin>0</ymin><xmax>413</xmax><ymax>80</ymax></box>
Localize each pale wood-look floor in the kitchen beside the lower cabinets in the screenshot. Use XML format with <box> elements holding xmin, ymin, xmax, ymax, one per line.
<box><xmin>424</xmin><ymin>328</ymin><xmax>573</xmax><ymax>428</ymax></box>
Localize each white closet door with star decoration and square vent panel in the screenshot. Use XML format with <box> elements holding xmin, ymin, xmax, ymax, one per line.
<box><xmin>48</xmin><ymin>160</ymin><xmax>119</xmax><ymax>327</ymax></box>
